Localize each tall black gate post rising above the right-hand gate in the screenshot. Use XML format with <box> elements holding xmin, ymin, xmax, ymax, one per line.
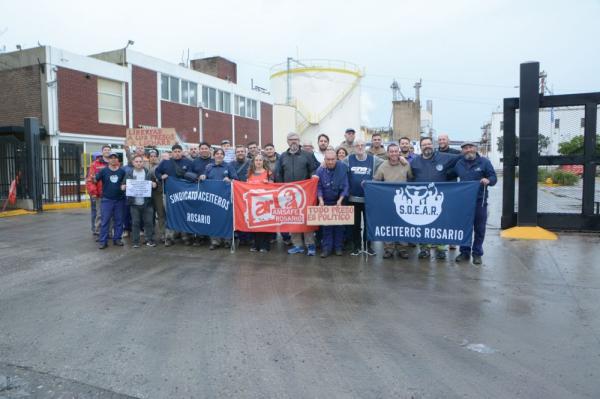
<box><xmin>517</xmin><ymin>62</ymin><xmax>540</xmax><ymax>226</ymax></box>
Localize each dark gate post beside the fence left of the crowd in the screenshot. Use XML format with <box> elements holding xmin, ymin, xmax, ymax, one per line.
<box><xmin>24</xmin><ymin>118</ymin><xmax>43</xmax><ymax>212</ymax></box>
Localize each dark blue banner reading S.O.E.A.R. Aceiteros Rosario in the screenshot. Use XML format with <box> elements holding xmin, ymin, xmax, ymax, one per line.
<box><xmin>365</xmin><ymin>181</ymin><xmax>480</xmax><ymax>246</ymax></box>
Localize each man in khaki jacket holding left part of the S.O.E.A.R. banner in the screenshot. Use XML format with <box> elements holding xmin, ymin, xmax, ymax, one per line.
<box><xmin>373</xmin><ymin>143</ymin><xmax>412</xmax><ymax>259</ymax></box>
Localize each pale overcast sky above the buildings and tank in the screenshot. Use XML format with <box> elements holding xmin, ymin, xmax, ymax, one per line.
<box><xmin>0</xmin><ymin>0</ymin><xmax>600</xmax><ymax>139</ymax></box>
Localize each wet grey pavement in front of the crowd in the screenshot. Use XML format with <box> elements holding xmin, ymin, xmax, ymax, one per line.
<box><xmin>0</xmin><ymin>207</ymin><xmax>600</xmax><ymax>398</ymax></box>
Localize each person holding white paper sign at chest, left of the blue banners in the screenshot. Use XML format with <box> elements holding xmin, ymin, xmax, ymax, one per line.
<box><xmin>121</xmin><ymin>155</ymin><xmax>156</xmax><ymax>248</ymax></box>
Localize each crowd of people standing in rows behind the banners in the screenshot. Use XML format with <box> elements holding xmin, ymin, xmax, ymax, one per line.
<box><xmin>86</xmin><ymin>129</ymin><xmax>497</xmax><ymax>264</ymax></box>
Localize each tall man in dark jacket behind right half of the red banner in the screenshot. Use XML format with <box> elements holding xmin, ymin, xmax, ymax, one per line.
<box><xmin>275</xmin><ymin>132</ymin><xmax>317</xmax><ymax>256</ymax></box>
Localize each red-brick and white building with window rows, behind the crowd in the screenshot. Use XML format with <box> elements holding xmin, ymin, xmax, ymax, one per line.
<box><xmin>0</xmin><ymin>46</ymin><xmax>273</xmax><ymax>159</ymax></box>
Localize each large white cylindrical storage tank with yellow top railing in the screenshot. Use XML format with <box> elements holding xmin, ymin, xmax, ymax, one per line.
<box><xmin>271</xmin><ymin>58</ymin><xmax>363</xmax><ymax>151</ymax></box>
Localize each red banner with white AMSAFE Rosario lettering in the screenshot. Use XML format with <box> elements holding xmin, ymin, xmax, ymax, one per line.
<box><xmin>233</xmin><ymin>179</ymin><xmax>318</xmax><ymax>233</ymax></box>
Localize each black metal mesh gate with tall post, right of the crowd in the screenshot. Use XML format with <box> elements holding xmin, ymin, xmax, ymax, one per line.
<box><xmin>501</xmin><ymin>63</ymin><xmax>600</xmax><ymax>231</ymax></box>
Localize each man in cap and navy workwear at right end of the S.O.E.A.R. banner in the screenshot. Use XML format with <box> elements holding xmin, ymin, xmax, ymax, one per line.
<box><xmin>454</xmin><ymin>142</ymin><xmax>498</xmax><ymax>265</ymax></box>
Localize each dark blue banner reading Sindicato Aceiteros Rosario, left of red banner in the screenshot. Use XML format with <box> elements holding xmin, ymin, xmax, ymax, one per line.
<box><xmin>165</xmin><ymin>177</ymin><xmax>233</xmax><ymax>238</ymax></box>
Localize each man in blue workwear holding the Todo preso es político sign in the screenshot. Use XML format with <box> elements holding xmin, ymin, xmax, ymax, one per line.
<box><xmin>317</xmin><ymin>150</ymin><xmax>349</xmax><ymax>258</ymax></box>
